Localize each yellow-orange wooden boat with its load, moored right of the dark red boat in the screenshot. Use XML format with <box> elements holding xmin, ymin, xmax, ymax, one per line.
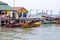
<box><xmin>20</xmin><ymin>20</ymin><xmax>42</xmax><ymax>28</ymax></box>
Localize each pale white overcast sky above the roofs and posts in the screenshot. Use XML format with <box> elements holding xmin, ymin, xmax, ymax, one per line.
<box><xmin>0</xmin><ymin>0</ymin><xmax>60</xmax><ymax>14</ymax></box>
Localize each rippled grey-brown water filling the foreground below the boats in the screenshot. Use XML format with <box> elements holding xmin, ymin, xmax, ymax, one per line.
<box><xmin>0</xmin><ymin>24</ymin><xmax>60</xmax><ymax>40</ymax></box>
